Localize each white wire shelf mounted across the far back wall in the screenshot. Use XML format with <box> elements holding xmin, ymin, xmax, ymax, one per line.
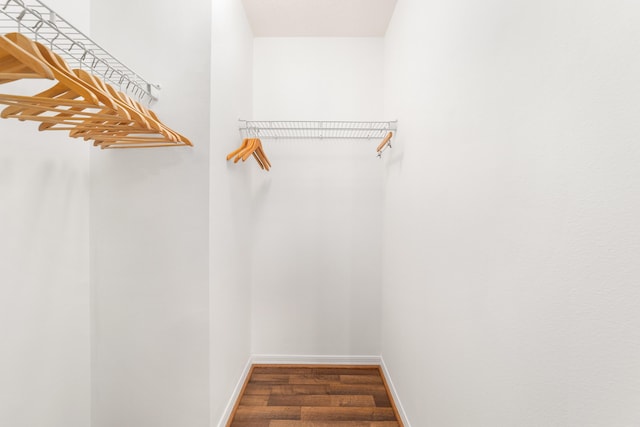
<box><xmin>240</xmin><ymin>120</ymin><xmax>398</xmax><ymax>140</ymax></box>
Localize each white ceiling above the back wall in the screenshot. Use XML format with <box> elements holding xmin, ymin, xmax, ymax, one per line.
<box><xmin>242</xmin><ymin>0</ymin><xmax>397</xmax><ymax>37</ymax></box>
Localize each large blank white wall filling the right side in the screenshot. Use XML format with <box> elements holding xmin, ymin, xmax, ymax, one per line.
<box><xmin>382</xmin><ymin>0</ymin><xmax>640</xmax><ymax>427</ymax></box>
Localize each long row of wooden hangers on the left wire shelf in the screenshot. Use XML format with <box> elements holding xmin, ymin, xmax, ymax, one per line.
<box><xmin>0</xmin><ymin>33</ymin><xmax>193</xmax><ymax>148</ymax></box>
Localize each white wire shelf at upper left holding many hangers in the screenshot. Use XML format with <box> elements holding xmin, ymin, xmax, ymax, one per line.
<box><xmin>0</xmin><ymin>0</ymin><xmax>160</xmax><ymax>105</ymax></box>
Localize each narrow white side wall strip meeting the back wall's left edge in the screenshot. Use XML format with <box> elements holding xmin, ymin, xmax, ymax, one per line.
<box><xmin>210</xmin><ymin>0</ymin><xmax>253</xmax><ymax>426</ymax></box>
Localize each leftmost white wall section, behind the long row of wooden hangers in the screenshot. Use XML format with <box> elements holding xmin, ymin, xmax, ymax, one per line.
<box><xmin>0</xmin><ymin>0</ymin><xmax>90</xmax><ymax>427</ymax></box>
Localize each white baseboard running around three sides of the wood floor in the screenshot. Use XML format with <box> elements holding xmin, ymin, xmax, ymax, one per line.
<box><xmin>218</xmin><ymin>354</ymin><xmax>411</xmax><ymax>427</ymax></box>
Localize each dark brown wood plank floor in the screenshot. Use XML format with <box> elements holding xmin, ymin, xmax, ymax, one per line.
<box><xmin>227</xmin><ymin>365</ymin><xmax>402</xmax><ymax>427</ymax></box>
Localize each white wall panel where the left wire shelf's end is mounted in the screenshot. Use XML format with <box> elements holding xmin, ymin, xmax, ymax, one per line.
<box><xmin>91</xmin><ymin>0</ymin><xmax>211</xmax><ymax>427</ymax></box>
